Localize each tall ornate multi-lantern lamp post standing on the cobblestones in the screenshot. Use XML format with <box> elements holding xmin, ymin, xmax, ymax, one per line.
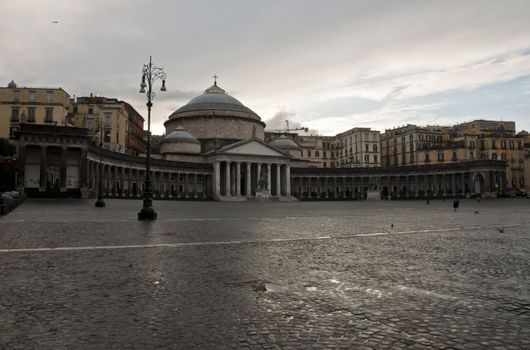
<box><xmin>138</xmin><ymin>56</ymin><xmax>166</xmax><ymax>220</ymax></box>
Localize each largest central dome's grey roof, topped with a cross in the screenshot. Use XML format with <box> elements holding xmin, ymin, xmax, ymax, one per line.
<box><xmin>169</xmin><ymin>83</ymin><xmax>259</xmax><ymax>119</ymax></box>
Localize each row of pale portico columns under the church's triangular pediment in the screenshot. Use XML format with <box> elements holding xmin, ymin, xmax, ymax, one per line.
<box><xmin>213</xmin><ymin>160</ymin><xmax>291</xmax><ymax>199</ymax></box>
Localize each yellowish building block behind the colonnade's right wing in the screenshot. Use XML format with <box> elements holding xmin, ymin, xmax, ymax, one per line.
<box><xmin>381</xmin><ymin>120</ymin><xmax>528</xmax><ymax>189</ymax></box>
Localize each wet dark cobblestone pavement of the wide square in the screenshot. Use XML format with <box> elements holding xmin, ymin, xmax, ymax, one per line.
<box><xmin>0</xmin><ymin>199</ymin><xmax>530</xmax><ymax>349</ymax></box>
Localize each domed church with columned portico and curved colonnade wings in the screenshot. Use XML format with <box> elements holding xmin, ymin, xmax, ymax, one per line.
<box><xmin>16</xmin><ymin>82</ymin><xmax>506</xmax><ymax>201</ymax></box>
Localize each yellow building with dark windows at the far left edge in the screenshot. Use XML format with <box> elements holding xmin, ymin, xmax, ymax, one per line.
<box><xmin>0</xmin><ymin>81</ymin><xmax>70</xmax><ymax>138</ymax></box>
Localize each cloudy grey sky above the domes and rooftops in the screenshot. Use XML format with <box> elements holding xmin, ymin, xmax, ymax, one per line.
<box><xmin>0</xmin><ymin>0</ymin><xmax>530</xmax><ymax>135</ymax></box>
